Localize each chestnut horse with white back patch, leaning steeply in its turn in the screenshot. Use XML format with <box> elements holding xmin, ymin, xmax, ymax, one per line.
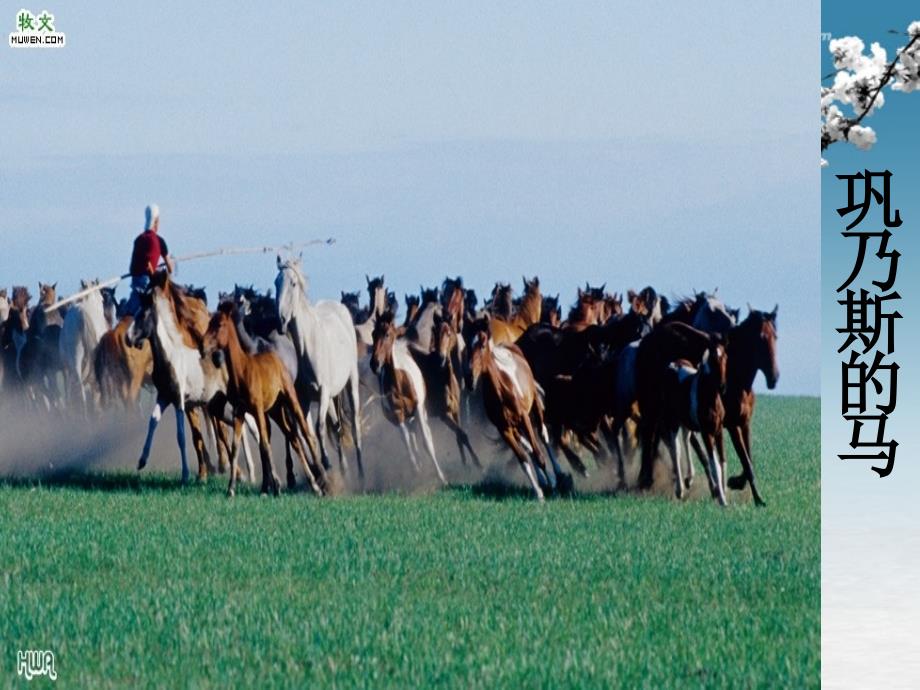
<box><xmin>469</xmin><ymin>314</ymin><xmax>563</xmax><ymax>501</ymax></box>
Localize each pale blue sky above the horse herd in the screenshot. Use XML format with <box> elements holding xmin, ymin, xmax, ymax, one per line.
<box><xmin>0</xmin><ymin>2</ymin><xmax>820</xmax><ymax>393</ymax></box>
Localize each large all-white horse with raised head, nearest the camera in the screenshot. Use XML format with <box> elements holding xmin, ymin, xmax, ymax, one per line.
<box><xmin>275</xmin><ymin>256</ymin><xmax>364</xmax><ymax>477</ymax></box>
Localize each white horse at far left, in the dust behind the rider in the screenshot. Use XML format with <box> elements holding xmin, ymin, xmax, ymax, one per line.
<box><xmin>60</xmin><ymin>280</ymin><xmax>108</xmax><ymax>412</ymax></box>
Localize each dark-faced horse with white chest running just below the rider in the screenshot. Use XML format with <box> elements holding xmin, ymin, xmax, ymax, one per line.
<box><xmin>125</xmin><ymin>272</ymin><xmax>244</xmax><ymax>483</ymax></box>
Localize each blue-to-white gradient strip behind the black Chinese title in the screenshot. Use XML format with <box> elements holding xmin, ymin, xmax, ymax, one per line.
<box><xmin>816</xmin><ymin>2</ymin><xmax>920</xmax><ymax>687</ymax></box>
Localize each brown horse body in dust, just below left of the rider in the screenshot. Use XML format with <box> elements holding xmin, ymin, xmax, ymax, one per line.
<box><xmin>93</xmin><ymin>315</ymin><xmax>153</xmax><ymax>407</ymax></box>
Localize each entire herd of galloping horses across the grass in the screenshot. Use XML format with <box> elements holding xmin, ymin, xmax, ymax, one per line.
<box><xmin>0</xmin><ymin>256</ymin><xmax>779</xmax><ymax>505</ymax></box>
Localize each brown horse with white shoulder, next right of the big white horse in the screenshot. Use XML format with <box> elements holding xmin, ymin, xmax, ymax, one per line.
<box><xmin>371</xmin><ymin>312</ymin><xmax>447</xmax><ymax>484</ymax></box>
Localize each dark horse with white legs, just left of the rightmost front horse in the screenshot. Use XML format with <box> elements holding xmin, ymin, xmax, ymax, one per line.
<box><xmin>656</xmin><ymin>334</ymin><xmax>728</xmax><ymax>506</ymax></box>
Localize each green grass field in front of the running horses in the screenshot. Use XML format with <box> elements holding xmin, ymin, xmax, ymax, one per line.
<box><xmin>0</xmin><ymin>397</ymin><xmax>821</xmax><ymax>688</ymax></box>
